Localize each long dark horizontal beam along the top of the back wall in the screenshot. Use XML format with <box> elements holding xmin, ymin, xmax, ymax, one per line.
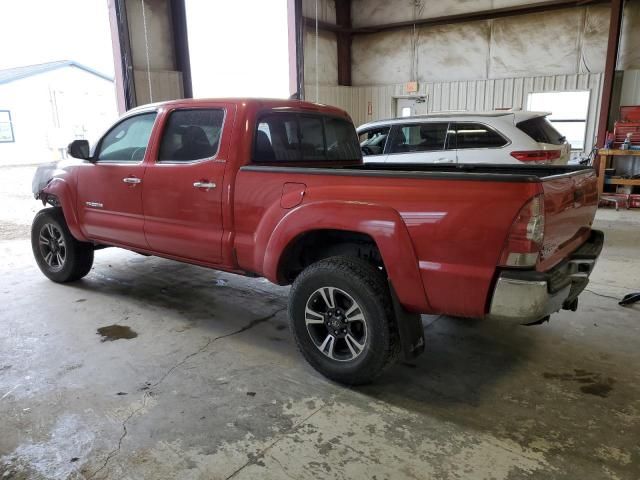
<box><xmin>304</xmin><ymin>0</ymin><xmax>610</xmax><ymax>35</ymax></box>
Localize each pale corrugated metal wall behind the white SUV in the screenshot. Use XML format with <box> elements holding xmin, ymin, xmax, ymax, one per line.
<box><xmin>306</xmin><ymin>73</ymin><xmax>602</xmax><ymax>151</ymax></box>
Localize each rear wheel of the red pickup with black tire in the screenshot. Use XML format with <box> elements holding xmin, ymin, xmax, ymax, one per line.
<box><xmin>289</xmin><ymin>257</ymin><xmax>399</xmax><ymax>385</ymax></box>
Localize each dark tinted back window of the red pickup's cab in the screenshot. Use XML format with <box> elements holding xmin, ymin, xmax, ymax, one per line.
<box><xmin>253</xmin><ymin>113</ymin><xmax>362</xmax><ymax>163</ymax></box>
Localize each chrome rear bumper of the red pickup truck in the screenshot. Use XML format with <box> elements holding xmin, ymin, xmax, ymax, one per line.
<box><xmin>488</xmin><ymin>230</ymin><xmax>604</xmax><ymax>323</ymax></box>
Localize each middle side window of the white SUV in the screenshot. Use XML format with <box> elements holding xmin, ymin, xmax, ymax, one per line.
<box><xmin>389</xmin><ymin>122</ymin><xmax>449</xmax><ymax>153</ymax></box>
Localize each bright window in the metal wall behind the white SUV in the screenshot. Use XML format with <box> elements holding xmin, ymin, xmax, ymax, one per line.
<box><xmin>527</xmin><ymin>90</ymin><xmax>591</xmax><ymax>150</ymax></box>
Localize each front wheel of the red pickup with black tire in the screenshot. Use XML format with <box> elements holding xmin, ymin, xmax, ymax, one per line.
<box><xmin>31</xmin><ymin>208</ymin><xmax>93</xmax><ymax>283</ymax></box>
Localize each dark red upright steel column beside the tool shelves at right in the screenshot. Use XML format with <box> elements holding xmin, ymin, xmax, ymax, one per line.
<box><xmin>596</xmin><ymin>0</ymin><xmax>624</xmax><ymax>148</ymax></box>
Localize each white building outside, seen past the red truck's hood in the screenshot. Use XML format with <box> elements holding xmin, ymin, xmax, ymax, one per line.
<box><xmin>0</xmin><ymin>61</ymin><xmax>118</xmax><ymax>165</ymax></box>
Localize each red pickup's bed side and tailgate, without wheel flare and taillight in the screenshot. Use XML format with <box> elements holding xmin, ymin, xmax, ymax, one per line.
<box><xmin>235</xmin><ymin>164</ymin><xmax>597</xmax><ymax>317</ymax></box>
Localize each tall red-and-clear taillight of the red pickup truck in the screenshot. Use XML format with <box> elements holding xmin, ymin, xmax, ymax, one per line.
<box><xmin>500</xmin><ymin>194</ymin><xmax>544</xmax><ymax>267</ymax></box>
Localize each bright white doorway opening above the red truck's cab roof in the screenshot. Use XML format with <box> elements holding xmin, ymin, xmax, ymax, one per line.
<box><xmin>186</xmin><ymin>0</ymin><xmax>289</xmax><ymax>98</ymax></box>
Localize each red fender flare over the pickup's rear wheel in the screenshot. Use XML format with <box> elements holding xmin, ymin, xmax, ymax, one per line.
<box><xmin>256</xmin><ymin>201</ymin><xmax>430</xmax><ymax>312</ymax></box>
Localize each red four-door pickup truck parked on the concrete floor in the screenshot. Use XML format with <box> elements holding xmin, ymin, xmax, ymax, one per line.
<box><xmin>32</xmin><ymin>99</ymin><xmax>603</xmax><ymax>384</ymax></box>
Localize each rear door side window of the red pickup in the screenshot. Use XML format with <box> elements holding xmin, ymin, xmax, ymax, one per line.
<box><xmin>158</xmin><ymin>109</ymin><xmax>224</xmax><ymax>162</ymax></box>
